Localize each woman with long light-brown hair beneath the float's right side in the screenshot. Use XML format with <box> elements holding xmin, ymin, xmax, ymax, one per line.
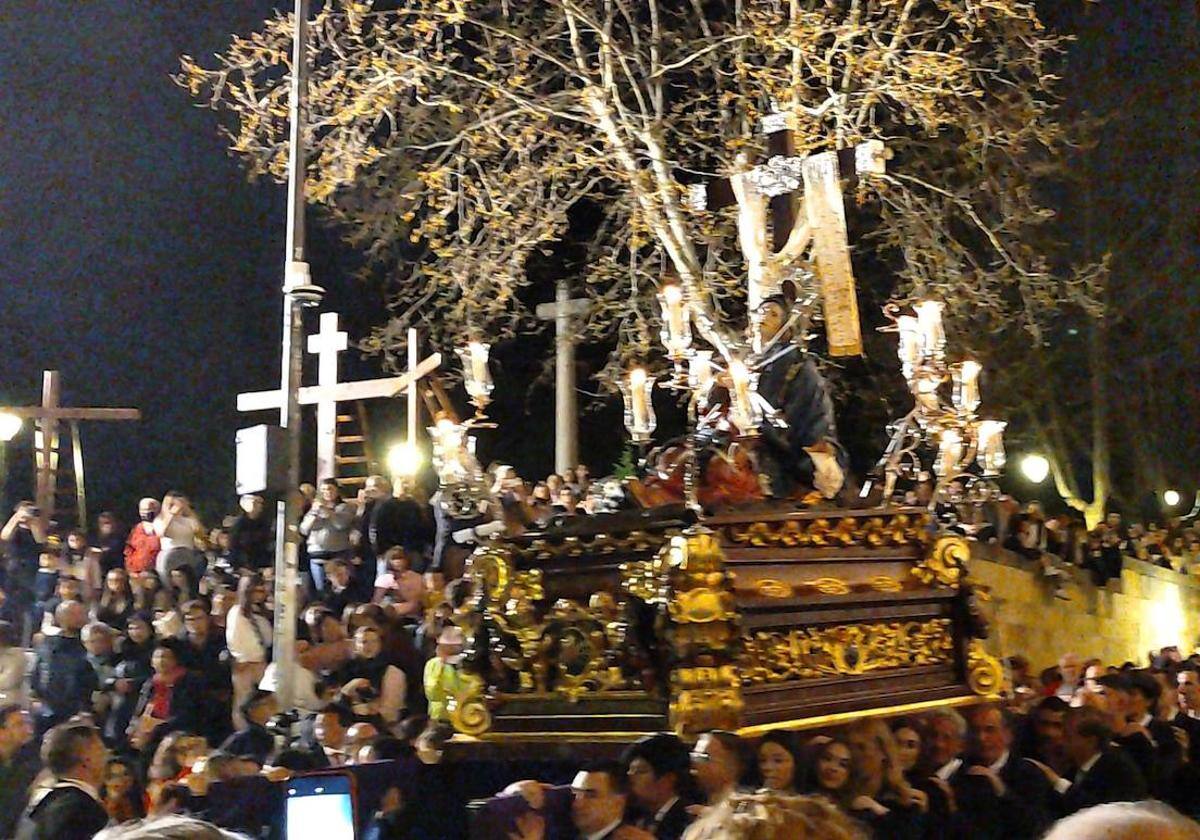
<box><xmin>846</xmin><ymin>720</ymin><xmax>929</xmax><ymax>839</ymax></box>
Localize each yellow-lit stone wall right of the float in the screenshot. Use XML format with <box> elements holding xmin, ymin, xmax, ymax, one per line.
<box><xmin>970</xmin><ymin>546</ymin><xmax>1200</xmax><ymax>672</ymax></box>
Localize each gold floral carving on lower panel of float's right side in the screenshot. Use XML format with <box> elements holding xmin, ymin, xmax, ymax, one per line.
<box><xmin>740</xmin><ymin>618</ymin><xmax>954</xmax><ymax>684</ymax></box>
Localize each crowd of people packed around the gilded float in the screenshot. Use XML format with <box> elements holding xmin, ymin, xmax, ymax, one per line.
<box><xmin>0</xmin><ymin>466</ymin><xmax>1200</xmax><ymax>840</ymax></box>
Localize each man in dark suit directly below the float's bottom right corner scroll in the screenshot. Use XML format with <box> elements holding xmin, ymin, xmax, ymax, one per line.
<box><xmin>967</xmin><ymin>706</ymin><xmax>1052</xmax><ymax>840</ymax></box>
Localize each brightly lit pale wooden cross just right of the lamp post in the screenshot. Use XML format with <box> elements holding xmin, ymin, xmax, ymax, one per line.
<box><xmin>238</xmin><ymin>312</ymin><xmax>442</xmax><ymax>481</ymax></box>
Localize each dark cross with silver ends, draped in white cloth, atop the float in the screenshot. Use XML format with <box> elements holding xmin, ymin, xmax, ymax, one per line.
<box><xmin>689</xmin><ymin>114</ymin><xmax>884</xmax><ymax>355</ymax></box>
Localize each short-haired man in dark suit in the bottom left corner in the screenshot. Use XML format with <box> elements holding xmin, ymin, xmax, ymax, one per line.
<box><xmin>17</xmin><ymin>721</ymin><xmax>108</xmax><ymax>840</ymax></box>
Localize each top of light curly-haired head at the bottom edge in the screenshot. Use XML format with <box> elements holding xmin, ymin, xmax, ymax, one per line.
<box><xmin>684</xmin><ymin>791</ymin><xmax>868</xmax><ymax>840</ymax></box>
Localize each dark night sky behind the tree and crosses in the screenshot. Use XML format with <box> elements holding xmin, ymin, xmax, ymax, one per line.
<box><xmin>0</xmin><ymin>0</ymin><xmax>1196</xmax><ymax>520</ymax></box>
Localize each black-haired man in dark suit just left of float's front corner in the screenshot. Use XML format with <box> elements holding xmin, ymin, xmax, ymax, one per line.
<box><xmin>620</xmin><ymin>732</ymin><xmax>694</xmax><ymax>840</ymax></box>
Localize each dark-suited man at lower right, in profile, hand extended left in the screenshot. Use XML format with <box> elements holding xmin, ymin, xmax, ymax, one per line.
<box><xmin>1039</xmin><ymin>706</ymin><xmax>1150</xmax><ymax>816</ymax></box>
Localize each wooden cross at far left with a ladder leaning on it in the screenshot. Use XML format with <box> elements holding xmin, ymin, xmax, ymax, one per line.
<box><xmin>2</xmin><ymin>371</ymin><xmax>142</xmax><ymax>520</ymax></box>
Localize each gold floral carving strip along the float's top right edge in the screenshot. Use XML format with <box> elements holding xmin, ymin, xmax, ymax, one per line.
<box><xmin>725</xmin><ymin>514</ymin><xmax>930</xmax><ymax>548</ymax></box>
